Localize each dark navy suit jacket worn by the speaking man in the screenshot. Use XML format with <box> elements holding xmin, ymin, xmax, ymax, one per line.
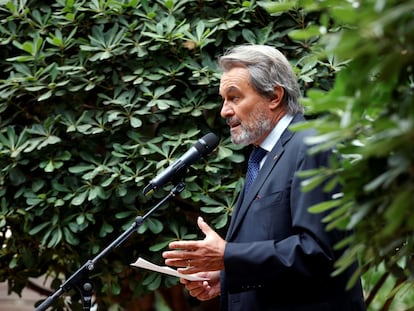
<box><xmin>221</xmin><ymin>115</ymin><xmax>365</xmax><ymax>311</ymax></box>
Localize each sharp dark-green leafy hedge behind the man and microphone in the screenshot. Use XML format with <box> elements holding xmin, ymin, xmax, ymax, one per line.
<box><xmin>0</xmin><ymin>0</ymin><xmax>332</xmax><ymax>309</ymax></box>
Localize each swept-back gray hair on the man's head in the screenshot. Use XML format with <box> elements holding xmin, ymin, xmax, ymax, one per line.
<box><xmin>219</xmin><ymin>45</ymin><xmax>304</xmax><ymax>115</ymax></box>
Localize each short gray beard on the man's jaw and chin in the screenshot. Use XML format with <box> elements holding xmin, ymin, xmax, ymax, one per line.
<box><xmin>231</xmin><ymin>110</ymin><xmax>272</xmax><ymax>146</ymax></box>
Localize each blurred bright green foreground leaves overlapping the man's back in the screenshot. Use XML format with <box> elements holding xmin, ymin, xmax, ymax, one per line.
<box><xmin>274</xmin><ymin>1</ymin><xmax>414</xmax><ymax>310</ymax></box>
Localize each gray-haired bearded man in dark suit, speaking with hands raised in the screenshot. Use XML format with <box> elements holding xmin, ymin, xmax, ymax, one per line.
<box><xmin>163</xmin><ymin>45</ymin><xmax>365</xmax><ymax>311</ymax></box>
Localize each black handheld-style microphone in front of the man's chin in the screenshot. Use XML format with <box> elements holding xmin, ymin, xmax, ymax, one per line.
<box><xmin>143</xmin><ymin>133</ymin><xmax>219</xmax><ymax>195</ymax></box>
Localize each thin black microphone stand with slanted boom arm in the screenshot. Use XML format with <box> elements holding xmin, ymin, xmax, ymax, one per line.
<box><xmin>35</xmin><ymin>181</ymin><xmax>185</xmax><ymax>311</ymax></box>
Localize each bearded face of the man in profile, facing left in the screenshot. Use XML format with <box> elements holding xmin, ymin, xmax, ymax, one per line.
<box><xmin>220</xmin><ymin>67</ymin><xmax>273</xmax><ymax>145</ymax></box>
